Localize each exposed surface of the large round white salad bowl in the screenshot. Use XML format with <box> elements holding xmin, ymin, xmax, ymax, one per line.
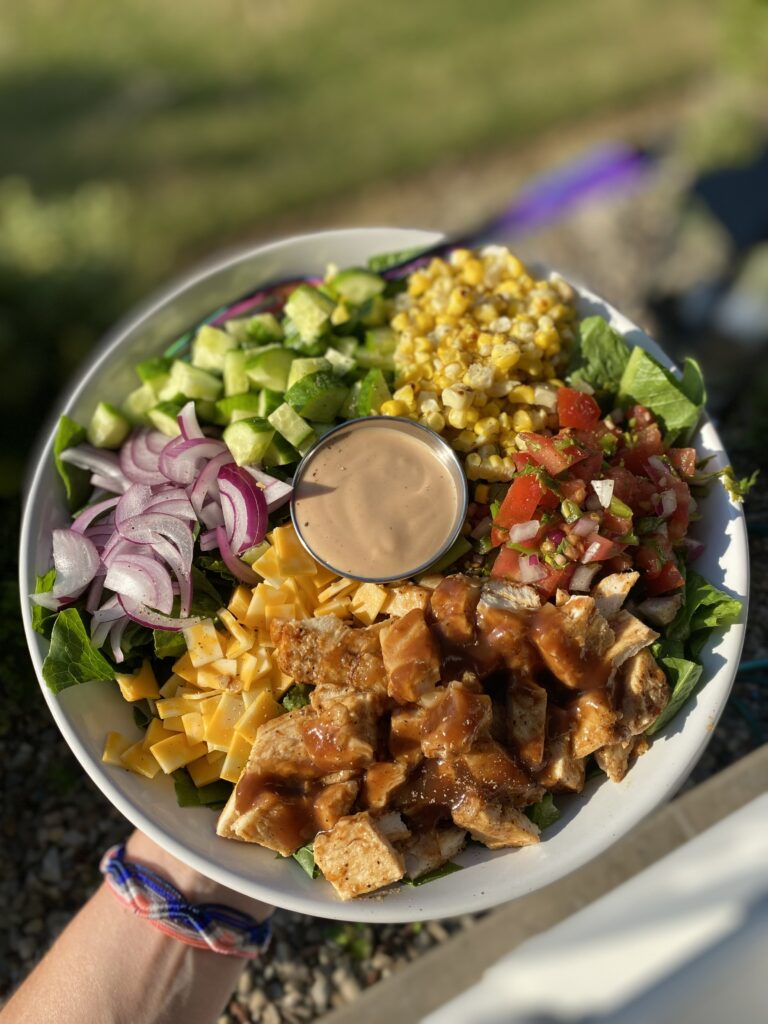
<box><xmin>19</xmin><ymin>228</ymin><xmax>749</xmax><ymax>922</ymax></box>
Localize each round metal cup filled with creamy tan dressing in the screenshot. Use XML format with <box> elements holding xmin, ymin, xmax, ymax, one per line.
<box><xmin>294</xmin><ymin>424</ymin><xmax>460</xmax><ymax>580</ymax></box>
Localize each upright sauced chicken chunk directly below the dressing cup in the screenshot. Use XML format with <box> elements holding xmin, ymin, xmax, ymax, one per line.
<box><xmin>381</xmin><ymin>608</ymin><xmax>440</xmax><ymax>703</ymax></box>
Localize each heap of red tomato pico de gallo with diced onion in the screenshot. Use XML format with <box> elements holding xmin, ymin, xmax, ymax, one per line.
<box><xmin>488</xmin><ymin>387</ymin><xmax>699</xmax><ymax>597</ymax></box>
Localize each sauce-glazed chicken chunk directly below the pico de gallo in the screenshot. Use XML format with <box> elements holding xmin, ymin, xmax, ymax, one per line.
<box><xmin>530</xmin><ymin>597</ymin><xmax>625</xmax><ymax>689</ymax></box>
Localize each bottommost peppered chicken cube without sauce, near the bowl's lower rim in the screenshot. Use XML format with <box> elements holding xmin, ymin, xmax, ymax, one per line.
<box><xmin>314</xmin><ymin>811</ymin><xmax>406</xmax><ymax>899</ymax></box>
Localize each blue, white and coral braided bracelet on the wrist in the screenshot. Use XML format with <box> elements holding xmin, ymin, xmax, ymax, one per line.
<box><xmin>98</xmin><ymin>843</ymin><xmax>271</xmax><ymax>959</ymax></box>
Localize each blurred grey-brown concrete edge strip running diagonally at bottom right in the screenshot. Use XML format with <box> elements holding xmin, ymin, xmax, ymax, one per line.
<box><xmin>323</xmin><ymin>744</ymin><xmax>768</xmax><ymax>1024</ymax></box>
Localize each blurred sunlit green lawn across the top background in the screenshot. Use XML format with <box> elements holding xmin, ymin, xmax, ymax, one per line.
<box><xmin>0</xmin><ymin>0</ymin><xmax>715</xmax><ymax>287</ymax></box>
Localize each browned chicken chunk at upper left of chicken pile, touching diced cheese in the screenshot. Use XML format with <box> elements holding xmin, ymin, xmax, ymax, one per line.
<box><xmin>269</xmin><ymin>615</ymin><xmax>386</xmax><ymax>693</ymax></box>
